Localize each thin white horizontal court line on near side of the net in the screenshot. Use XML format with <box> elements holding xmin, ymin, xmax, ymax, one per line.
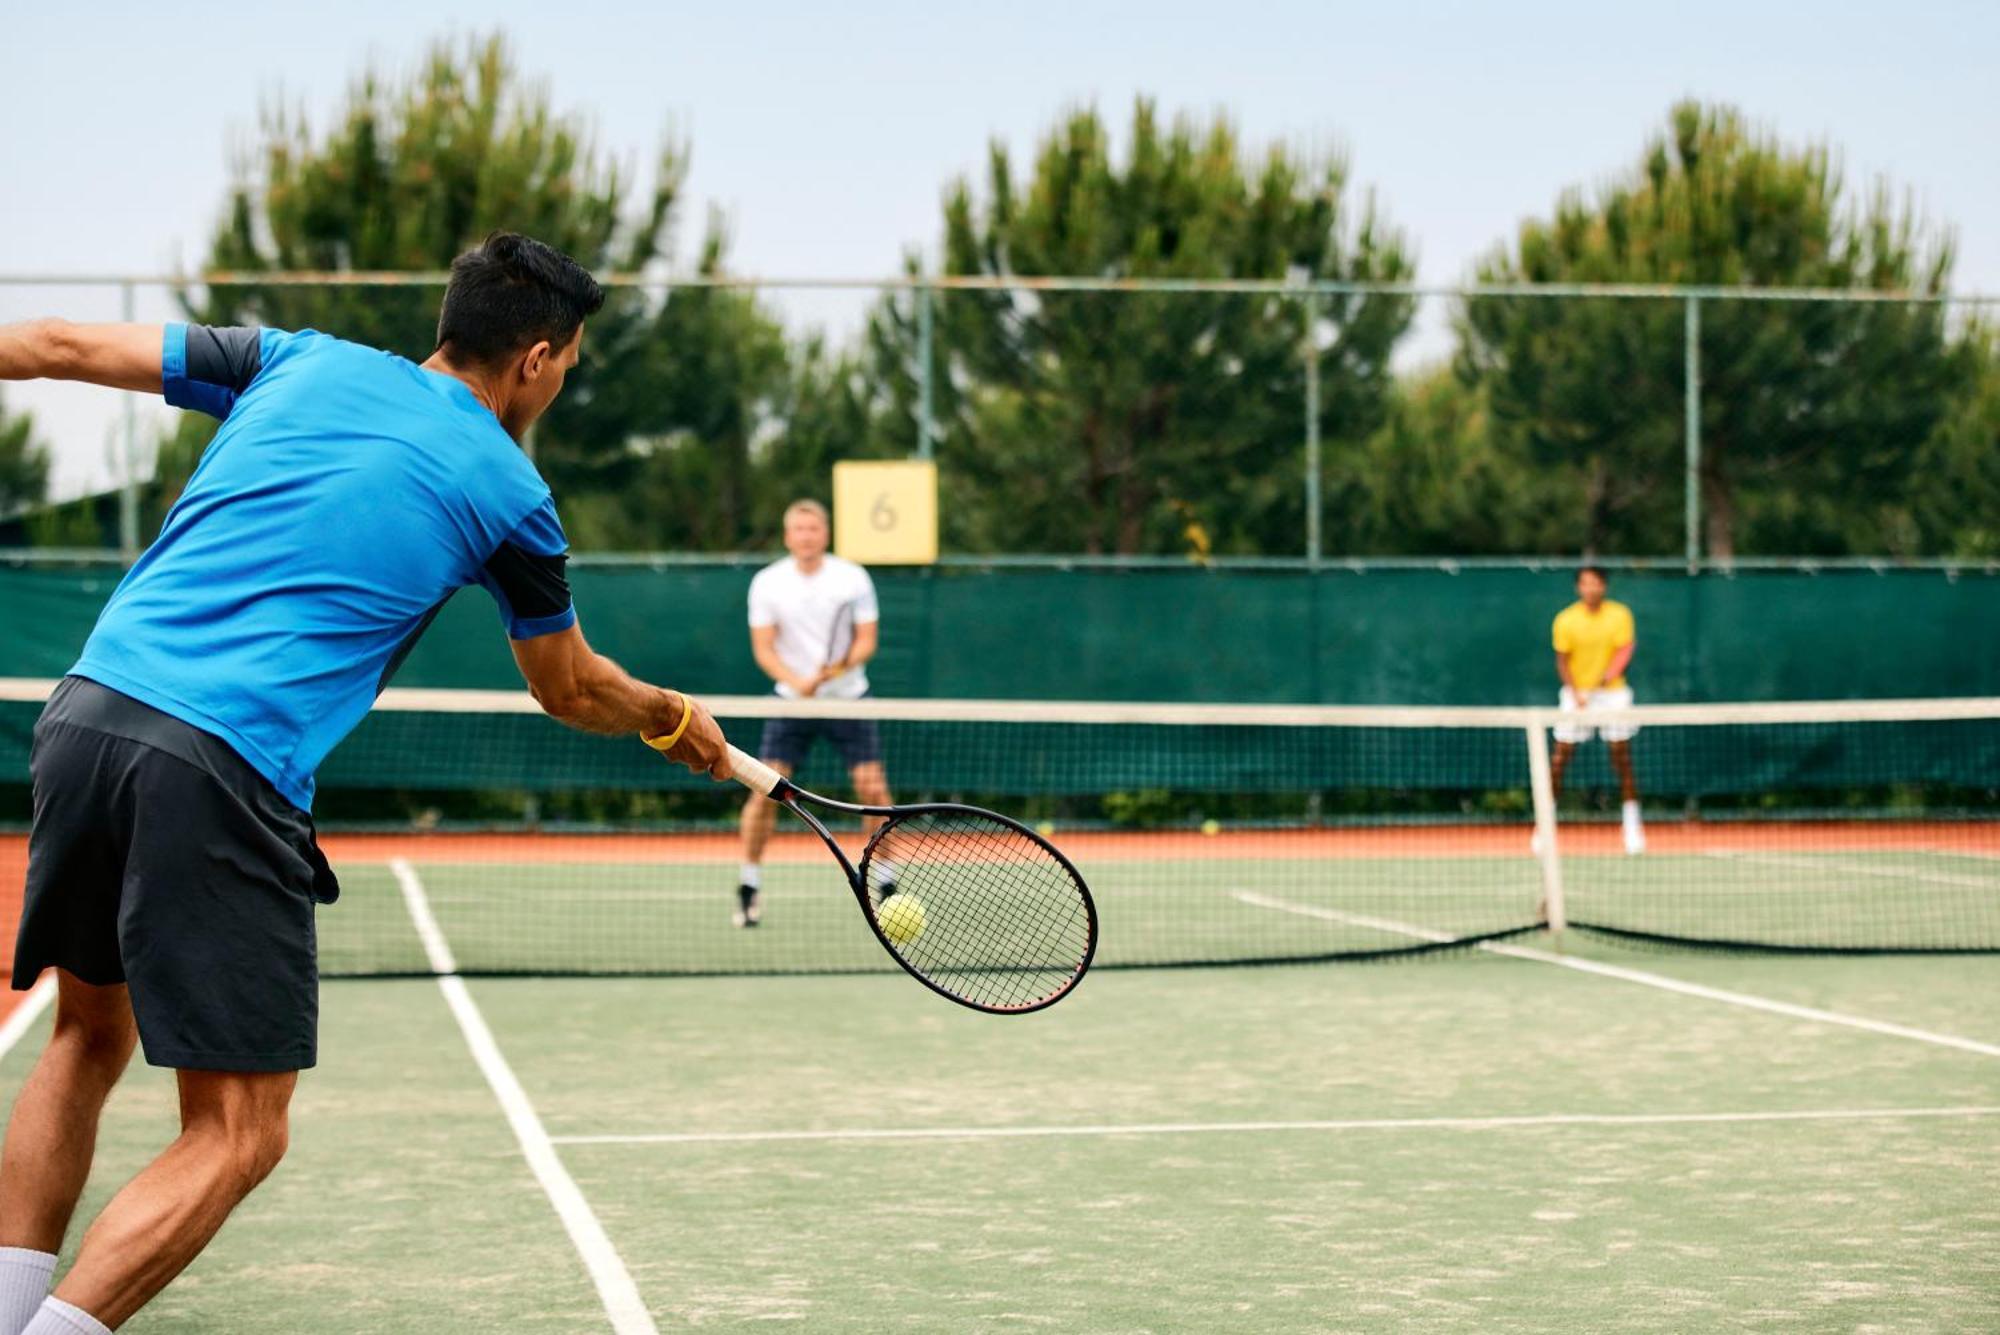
<box><xmin>554</xmin><ymin>1105</ymin><xmax>2000</xmax><ymax>1145</ymax></box>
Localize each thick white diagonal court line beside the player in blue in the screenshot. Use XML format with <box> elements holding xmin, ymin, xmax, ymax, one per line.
<box><xmin>388</xmin><ymin>857</ymin><xmax>658</xmax><ymax>1335</ymax></box>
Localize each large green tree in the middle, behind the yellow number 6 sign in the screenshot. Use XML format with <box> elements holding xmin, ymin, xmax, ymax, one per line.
<box><xmin>870</xmin><ymin>100</ymin><xmax>1412</xmax><ymax>554</ymax></box>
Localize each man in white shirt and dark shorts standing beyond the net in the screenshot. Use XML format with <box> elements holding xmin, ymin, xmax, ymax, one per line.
<box><xmin>736</xmin><ymin>500</ymin><xmax>894</xmax><ymax>927</ymax></box>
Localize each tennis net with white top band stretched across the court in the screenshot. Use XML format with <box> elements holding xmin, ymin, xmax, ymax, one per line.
<box><xmin>0</xmin><ymin>681</ymin><xmax>2000</xmax><ymax>975</ymax></box>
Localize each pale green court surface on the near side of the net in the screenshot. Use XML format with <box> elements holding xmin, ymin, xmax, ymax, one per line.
<box><xmin>0</xmin><ymin>935</ymin><xmax>2000</xmax><ymax>1333</ymax></box>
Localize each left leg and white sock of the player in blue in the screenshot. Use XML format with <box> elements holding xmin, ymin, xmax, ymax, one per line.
<box><xmin>0</xmin><ymin>969</ymin><xmax>138</xmax><ymax>1331</ymax></box>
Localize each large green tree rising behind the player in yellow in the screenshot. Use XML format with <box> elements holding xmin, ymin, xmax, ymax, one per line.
<box><xmin>1460</xmin><ymin>102</ymin><xmax>1964</xmax><ymax>558</ymax></box>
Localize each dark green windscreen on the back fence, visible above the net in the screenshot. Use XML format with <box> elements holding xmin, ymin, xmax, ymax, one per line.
<box><xmin>0</xmin><ymin>560</ymin><xmax>2000</xmax><ymax>705</ymax></box>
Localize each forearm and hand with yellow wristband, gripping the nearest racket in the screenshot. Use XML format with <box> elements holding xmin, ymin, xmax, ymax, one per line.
<box><xmin>508</xmin><ymin>626</ymin><xmax>730</xmax><ymax>779</ymax></box>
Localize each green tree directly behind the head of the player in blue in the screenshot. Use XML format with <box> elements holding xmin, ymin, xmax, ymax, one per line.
<box><xmin>168</xmin><ymin>38</ymin><xmax>790</xmax><ymax>548</ymax></box>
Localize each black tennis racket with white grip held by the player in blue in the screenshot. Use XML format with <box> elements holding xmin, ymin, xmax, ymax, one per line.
<box><xmin>730</xmin><ymin>745</ymin><xmax>1098</xmax><ymax>1015</ymax></box>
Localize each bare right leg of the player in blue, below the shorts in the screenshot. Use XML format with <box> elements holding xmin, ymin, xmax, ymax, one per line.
<box><xmin>56</xmin><ymin>1071</ymin><xmax>298</xmax><ymax>1329</ymax></box>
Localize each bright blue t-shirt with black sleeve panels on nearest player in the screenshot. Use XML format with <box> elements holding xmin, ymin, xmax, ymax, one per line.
<box><xmin>72</xmin><ymin>324</ymin><xmax>576</xmax><ymax>809</ymax></box>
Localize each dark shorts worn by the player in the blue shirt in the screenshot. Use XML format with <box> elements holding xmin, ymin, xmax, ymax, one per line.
<box><xmin>14</xmin><ymin>677</ymin><xmax>338</xmax><ymax>1071</ymax></box>
